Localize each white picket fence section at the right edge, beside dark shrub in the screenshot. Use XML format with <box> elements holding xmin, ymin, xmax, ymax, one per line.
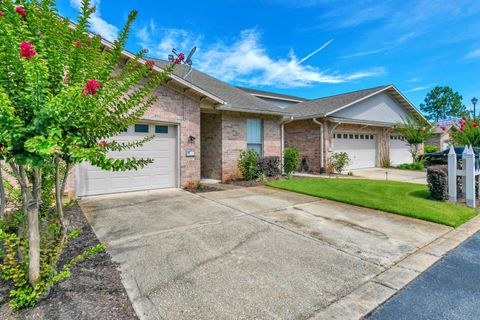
<box><xmin>448</xmin><ymin>146</ymin><xmax>480</xmax><ymax>208</ymax></box>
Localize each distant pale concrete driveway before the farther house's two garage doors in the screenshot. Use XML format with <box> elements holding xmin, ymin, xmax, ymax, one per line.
<box><xmin>352</xmin><ymin>168</ymin><xmax>427</xmax><ymax>184</ymax></box>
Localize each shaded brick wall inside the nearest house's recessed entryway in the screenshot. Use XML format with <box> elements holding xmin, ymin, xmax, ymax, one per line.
<box><xmin>200</xmin><ymin>113</ymin><xmax>222</xmax><ymax>180</ymax></box>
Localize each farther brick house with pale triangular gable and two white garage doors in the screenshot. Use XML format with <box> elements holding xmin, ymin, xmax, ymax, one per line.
<box><xmin>249</xmin><ymin>85</ymin><xmax>428</xmax><ymax>172</ymax></box>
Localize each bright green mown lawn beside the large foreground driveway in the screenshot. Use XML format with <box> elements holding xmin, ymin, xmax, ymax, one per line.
<box><xmin>267</xmin><ymin>178</ymin><xmax>477</xmax><ymax>227</ymax></box>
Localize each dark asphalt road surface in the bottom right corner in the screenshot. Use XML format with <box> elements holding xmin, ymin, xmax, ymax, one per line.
<box><xmin>368</xmin><ymin>233</ymin><xmax>480</xmax><ymax>320</ymax></box>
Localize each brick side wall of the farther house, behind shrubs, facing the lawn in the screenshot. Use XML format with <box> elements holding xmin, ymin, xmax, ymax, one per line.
<box><xmin>284</xmin><ymin>119</ymin><xmax>320</xmax><ymax>172</ymax></box>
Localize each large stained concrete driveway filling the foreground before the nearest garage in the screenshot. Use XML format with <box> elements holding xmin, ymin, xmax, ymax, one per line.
<box><xmin>80</xmin><ymin>187</ymin><xmax>450</xmax><ymax>319</ymax></box>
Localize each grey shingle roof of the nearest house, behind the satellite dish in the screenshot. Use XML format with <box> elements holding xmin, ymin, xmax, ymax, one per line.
<box><xmin>153</xmin><ymin>59</ymin><xmax>290</xmax><ymax>116</ymax></box>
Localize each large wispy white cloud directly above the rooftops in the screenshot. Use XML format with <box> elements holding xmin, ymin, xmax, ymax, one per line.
<box><xmin>137</xmin><ymin>26</ymin><xmax>385</xmax><ymax>88</ymax></box>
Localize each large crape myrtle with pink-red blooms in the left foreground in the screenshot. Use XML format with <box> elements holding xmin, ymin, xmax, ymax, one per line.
<box><xmin>0</xmin><ymin>0</ymin><xmax>173</xmax><ymax>287</ymax></box>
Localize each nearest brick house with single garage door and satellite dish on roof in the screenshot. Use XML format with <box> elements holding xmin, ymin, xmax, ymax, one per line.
<box><xmin>66</xmin><ymin>60</ymin><xmax>289</xmax><ymax>196</ymax></box>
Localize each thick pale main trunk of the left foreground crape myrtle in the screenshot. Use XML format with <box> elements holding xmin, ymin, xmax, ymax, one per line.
<box><xmin>27</xmin><ymin>168</ymin><xmax>42</xmax><ymax>286</ymax></box>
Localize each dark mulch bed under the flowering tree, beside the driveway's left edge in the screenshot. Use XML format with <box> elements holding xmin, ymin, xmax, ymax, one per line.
<box><xmin>0</xmin><ymin>205</ymin><xmax>138</xmax><ymax>320</ymax></box>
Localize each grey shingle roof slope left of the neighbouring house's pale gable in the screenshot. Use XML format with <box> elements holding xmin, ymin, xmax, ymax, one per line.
<box><xmin>285</xmin><ymin>86</ymin><xmax>389</xmax><ymax>117</ymax></box>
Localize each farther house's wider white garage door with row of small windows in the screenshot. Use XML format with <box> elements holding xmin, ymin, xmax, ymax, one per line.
<box><xmin>333</xmin><ymin>132</ymin><xmax>377</xmax><ymax>170</ymax></box>
